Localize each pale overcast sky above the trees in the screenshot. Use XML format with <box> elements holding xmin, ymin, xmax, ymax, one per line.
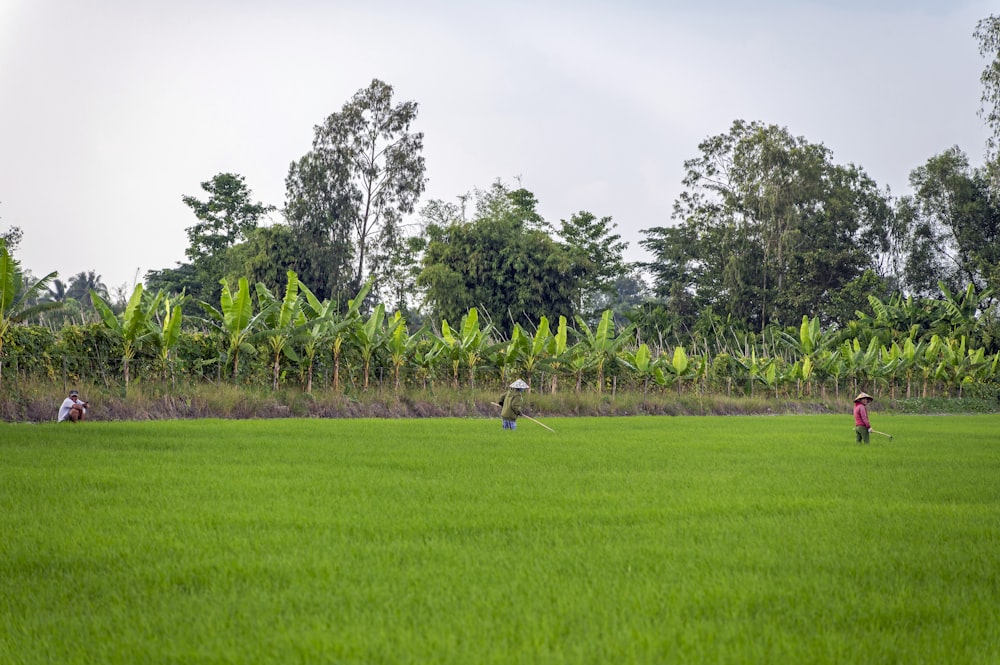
<box><xmin>0</xmin><ymin>0</ymin><xmax>997</xmax><ymax>292</ymax></box>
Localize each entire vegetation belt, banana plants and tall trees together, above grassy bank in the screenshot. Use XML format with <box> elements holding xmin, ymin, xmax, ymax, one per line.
<box><xmin>7</xmin><ymin>22</ymin><xmax>1000</xmax><ymax>397</ymax></box>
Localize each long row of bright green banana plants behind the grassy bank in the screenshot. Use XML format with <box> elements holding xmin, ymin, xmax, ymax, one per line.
<box><xmin>0</xmin><ymin>246</ymin><xmax>1000</xmax><ymax>399</ymax></box>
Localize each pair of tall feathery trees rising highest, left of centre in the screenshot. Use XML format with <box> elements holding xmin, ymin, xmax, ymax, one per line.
<box><xmin>286</xmin><ymin>79</ymin><xmax>426</xmax><ymax>306</ymax></box>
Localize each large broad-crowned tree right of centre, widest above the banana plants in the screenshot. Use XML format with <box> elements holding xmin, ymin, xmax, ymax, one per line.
<box><xmin>640</xmin><ymin>120</ymin><xmax>893</xmax><ymax>329</ymax></box>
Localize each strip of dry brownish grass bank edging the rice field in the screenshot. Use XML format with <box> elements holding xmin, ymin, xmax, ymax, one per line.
<box><xmin>0</xmin><ymin>382</ymin><xmax>1000</xmax><ymax>423</ymax></box>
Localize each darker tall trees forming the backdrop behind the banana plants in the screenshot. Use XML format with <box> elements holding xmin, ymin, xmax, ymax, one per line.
<box><xmin>0</xmin><ymin>16</ymin><xmax>1000</xmax><ymax>396</ymax></box>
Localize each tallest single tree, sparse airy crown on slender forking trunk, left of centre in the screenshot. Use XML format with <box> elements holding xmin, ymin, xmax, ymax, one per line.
<box><xmin>313</xmin><ymin>79</ymin><xmax>426</xmax><ymax>298</ymax></box>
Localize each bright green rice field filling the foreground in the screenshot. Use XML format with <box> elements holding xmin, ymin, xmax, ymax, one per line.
<box><xmin>0</xmin><ymin>414</ymin><xmax>1000</xmax><ymax>665</ymax></box>
